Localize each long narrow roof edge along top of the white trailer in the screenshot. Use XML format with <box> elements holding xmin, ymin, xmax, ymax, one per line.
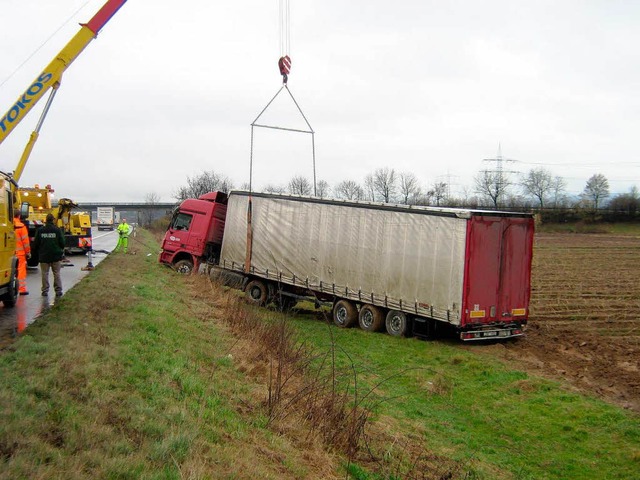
<box><xmin>229</xmin><ymin>190</ymin><xmax>533</xmax><ymax>218</ymax></box>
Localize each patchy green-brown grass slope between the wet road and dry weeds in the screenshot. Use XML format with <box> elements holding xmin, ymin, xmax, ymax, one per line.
<box><xmin>0</xmin><ymin>231</ymin><xmax>330</xmax><ymax>479</ymax></box>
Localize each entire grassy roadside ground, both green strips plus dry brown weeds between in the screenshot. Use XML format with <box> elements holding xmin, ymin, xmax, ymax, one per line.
<box><xmin>0</xmin><ymin>230</ymin><xmax>640</xmax><ymax>479</ymax></box>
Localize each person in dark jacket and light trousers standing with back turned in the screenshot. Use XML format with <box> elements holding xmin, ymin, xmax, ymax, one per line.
<box><xmin>33</xmin><ymin>213</ymin><xmax>64</xmax><ymax>297</ymax></box>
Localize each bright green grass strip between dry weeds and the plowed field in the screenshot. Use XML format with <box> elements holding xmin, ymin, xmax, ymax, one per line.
<box><xmin>284</xmin><ymin>306</ymin><xmax>640</xmax><ymax>479</ymax></box>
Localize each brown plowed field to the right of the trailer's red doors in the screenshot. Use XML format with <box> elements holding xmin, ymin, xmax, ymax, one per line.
<box><xmin>470</xmin><ymin>233</ymin><xmax>640</xmax><ymax>412</ymax></box>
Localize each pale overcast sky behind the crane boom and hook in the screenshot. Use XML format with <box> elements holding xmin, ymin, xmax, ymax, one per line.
<box><xmin>0</xmin><ymin>0</ymin><xmax>640</xmax><ymax>202</ymax></box>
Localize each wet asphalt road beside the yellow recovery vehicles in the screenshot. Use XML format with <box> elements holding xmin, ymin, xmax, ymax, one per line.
<box><xmin>0</xmin><ymin>228</ymin><xmax>119</xmax><ymax>348</ymax></box>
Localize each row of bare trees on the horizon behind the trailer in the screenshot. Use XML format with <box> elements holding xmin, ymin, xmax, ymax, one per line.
<box><xmin>174</xmin><ymin>167</ymin><xmax>640</xmax><ymax>218</ymax></box>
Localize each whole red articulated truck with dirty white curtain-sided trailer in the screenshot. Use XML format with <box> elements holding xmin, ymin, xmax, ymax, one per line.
<box><xmin>159</xmin><ymin>191</ymin><xmax>534</xmax><ymax>341</ymax></box>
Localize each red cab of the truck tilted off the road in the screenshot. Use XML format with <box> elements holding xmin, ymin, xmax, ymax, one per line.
<box><xmin>159</xmin><ymin>192</ymin><xmax>227</xmax><ymax>273</ymax></box>
